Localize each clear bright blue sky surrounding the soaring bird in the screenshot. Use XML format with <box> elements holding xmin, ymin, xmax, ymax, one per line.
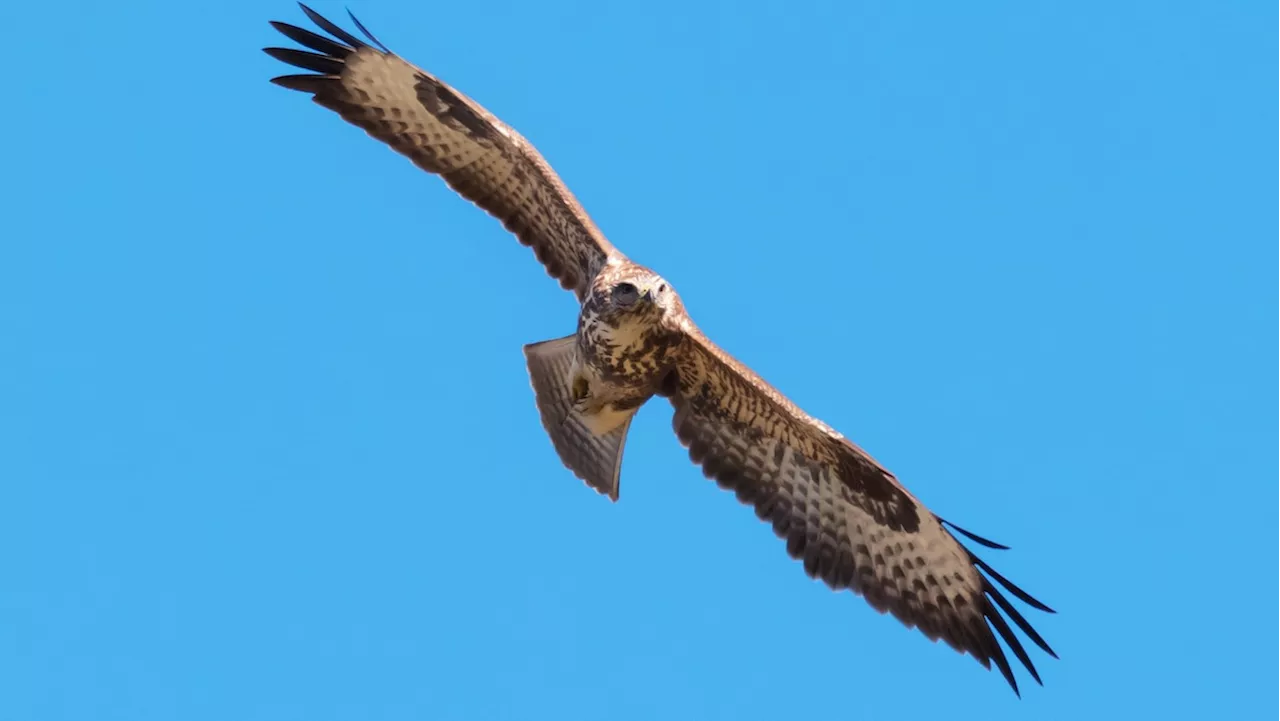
<box><xmin>0</xmin><ymin>0</ymin><xmax>1280</xmax><ymax>721</ymax></box>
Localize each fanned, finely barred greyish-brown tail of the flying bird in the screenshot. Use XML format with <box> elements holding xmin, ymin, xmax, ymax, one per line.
<box><xmin>525</xmin><ymin>336</ymin><xmax>631</xmax><ymax>501</ymax></box>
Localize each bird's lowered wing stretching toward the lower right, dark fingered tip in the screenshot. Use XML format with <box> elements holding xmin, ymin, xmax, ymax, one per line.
<box><xmin>662</xmin><ymin>323</ymin><xmax>1057</xmax><ymax>693</ymax></box>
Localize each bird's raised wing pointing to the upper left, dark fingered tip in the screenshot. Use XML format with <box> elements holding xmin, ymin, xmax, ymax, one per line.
<box><xmin>265</xmin><ymin>3</ymin><xmax>621</xmax><ymax>300</ymax></box>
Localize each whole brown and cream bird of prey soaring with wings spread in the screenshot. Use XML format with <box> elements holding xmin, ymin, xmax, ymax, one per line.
<box><xmin>265</xmin><ymin>5</ymin><xmax>1057</xmax><ymax>695</ymax></box>
